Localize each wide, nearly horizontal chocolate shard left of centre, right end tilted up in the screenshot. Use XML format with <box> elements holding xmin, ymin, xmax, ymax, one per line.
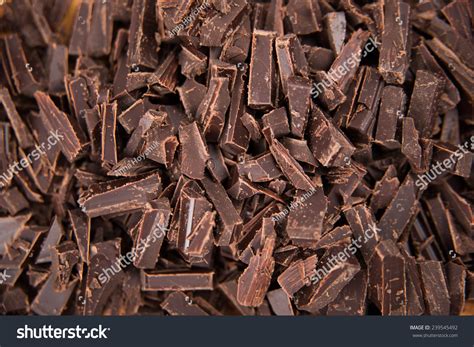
<box><xmin>79</xmin><ymin>174</ymin><xmax>161</xmax><ymax>218</ymax></box>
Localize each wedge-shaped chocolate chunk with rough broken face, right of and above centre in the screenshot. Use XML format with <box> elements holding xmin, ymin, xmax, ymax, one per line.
<box><xmin>309</xmin><ymin>108</ymin><xmax>355</xmax><ymax>167</ymax></box>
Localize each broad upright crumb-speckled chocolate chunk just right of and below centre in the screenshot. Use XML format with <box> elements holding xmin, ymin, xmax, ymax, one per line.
<box><xmin>286</xmin><ymin>187</ymin><xmax>328</xmax><ymax>246</ymax></box>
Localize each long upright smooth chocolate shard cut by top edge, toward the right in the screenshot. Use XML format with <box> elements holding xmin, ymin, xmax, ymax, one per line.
<box><xmin>379</xmin><ymin>0</ymin><xmax>410</xmax><ymax>84</ymax></box>
